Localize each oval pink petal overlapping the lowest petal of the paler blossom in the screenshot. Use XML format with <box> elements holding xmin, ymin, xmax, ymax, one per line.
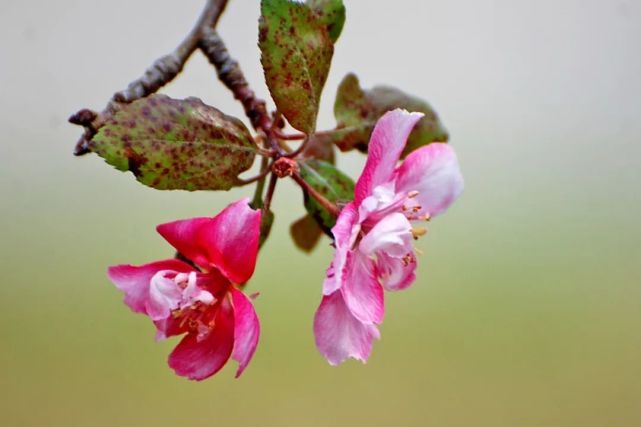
<box><xmin>339</xmin><ymin>251</ymin><xmax>385</xmax><ymax>323</ymax></box>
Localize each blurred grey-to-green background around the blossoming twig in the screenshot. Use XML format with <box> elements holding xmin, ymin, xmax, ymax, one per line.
<box><xmin>0</xmin><ymin>0</ymin><xmax>641</xmax><ymax>427</ymax></box>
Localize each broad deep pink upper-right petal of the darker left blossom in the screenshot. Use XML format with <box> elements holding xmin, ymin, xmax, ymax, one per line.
<box><xmin>198</xmin><ymin>198</ymin><xmax>261</xmax><ymax>284</ymax></box>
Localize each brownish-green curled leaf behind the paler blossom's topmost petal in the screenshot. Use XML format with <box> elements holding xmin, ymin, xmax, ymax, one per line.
<box><xmin>327</xmin><ymin>73</ymin><xmax>449</xmax><ymax>156</ymax></box>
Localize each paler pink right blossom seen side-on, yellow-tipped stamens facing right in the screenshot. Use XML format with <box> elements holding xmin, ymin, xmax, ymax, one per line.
<box><xmin>314</xmin><ymin>109</ymin><xmax>463</xmax><ymax>365</ymax></box>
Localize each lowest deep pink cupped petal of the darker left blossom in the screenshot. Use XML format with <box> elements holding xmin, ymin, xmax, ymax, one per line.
<box><xmin>169</xmin><ymin>298</ymin><xmax>234</xmax><ymax>380</ymax></box>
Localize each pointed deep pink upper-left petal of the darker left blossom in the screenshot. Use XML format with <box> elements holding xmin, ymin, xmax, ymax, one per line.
<box><xmin>156</xmin><ymin>217</ymin><xmax>212</xmax><ymax>267</ymax></box>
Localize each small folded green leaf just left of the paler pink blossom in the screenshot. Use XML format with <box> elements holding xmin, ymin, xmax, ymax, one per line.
<box><xmin>300</xmin><ymin>160</ymin><xmax>354</xmax><ymax>236</ymax></box>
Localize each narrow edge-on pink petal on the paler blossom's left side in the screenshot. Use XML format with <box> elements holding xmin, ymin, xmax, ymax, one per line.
<box><xmin>323</xmin><ymin>203</ymin><xmax>358</xmax><ymax>295</ymax></box>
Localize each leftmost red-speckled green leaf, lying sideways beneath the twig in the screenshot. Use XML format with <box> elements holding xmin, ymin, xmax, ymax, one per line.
<box><xmin>89</xmin><ymin>95</ymin><xmax>257</xmax><ymax>191</ymax></box>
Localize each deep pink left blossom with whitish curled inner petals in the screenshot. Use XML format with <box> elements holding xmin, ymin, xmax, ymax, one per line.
<box><xmin>108</xmin><ymin>199</ymin><xmax>261</xmax><ymax>380</ymax></box>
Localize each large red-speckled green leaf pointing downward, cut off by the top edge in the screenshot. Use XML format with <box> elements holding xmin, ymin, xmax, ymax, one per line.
<box><xmin>258</xmin><ymin>0</ymin><xmax>334</xmax><ymax>134</ymax></box>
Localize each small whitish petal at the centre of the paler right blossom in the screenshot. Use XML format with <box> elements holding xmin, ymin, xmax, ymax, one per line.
<box><xmin>359</xmin><ymin>212</ymin><xmax>413</xmax><ymax>257</ymax></box>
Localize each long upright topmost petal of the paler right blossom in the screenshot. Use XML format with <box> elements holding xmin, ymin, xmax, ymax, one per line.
<box><xmin>354</xmin><ymin>109</ymin><xmax>423</xmax><ymax>206</ymax></box>
